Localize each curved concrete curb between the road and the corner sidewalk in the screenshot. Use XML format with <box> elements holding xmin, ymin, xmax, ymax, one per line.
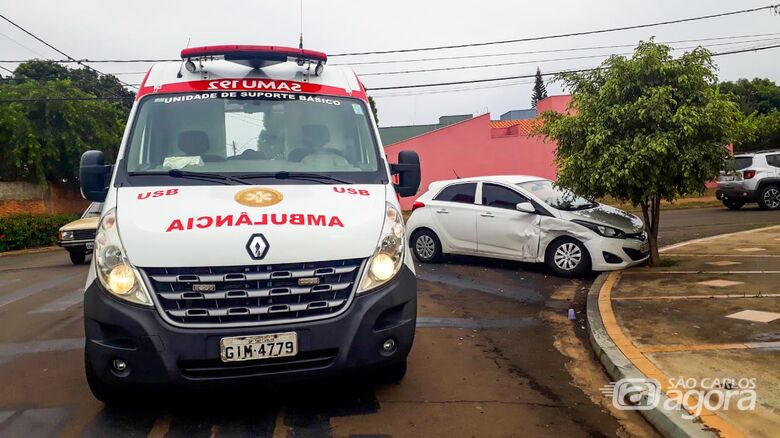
<box><xmin>586</xmin><ymin>272</ymin><xmax>718</xmax><ymax>438</ymax></box>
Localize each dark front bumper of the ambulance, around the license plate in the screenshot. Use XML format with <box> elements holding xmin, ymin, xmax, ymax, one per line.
<box><xmin>84</xmin><ymin>266</ymin><xmax>417</xmax><ymax>389</ymax></box>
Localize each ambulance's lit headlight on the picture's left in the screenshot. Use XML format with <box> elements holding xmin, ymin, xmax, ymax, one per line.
<box><xmin>94</xmin><ymin>209</ymin><xmax>152</xmax><ymax>306</ymax></box>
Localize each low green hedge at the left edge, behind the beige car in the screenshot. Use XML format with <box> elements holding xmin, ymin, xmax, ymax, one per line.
<box><xmin>0</xmin><ymin>213</ymin><xmax>78</xmax><ymax>252</ymax></box>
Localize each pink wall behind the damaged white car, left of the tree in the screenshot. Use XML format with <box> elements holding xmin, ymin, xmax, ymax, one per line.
<box><xmin>385</xmin><ymin>112</ymin><xmax>556</xmax><ymax>210</ymax></box>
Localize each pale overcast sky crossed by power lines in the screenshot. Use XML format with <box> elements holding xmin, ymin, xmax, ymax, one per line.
<box><xmin>0</xmin><ymin>0</ymin><xmax>780</xmax><ymax>126</ymax></box>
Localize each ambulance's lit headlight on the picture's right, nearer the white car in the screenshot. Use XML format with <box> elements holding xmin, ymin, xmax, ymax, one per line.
<box><xmin>357</xmin><ymin>202</ymin><xmax>406</xmax><ymax>294</ymax></box>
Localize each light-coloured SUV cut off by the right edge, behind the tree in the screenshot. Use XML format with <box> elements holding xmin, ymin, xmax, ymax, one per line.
<box><xmin>715</xmin><ymin>149</ymin><xmax>780</xmax><ymax>210</ymax></box>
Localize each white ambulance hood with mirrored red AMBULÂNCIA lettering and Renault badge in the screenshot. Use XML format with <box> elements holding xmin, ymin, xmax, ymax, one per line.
<box><xmin>116</xmin><ymin>184</ymin><xmax>386</xmax><ymax>268</ymax></box>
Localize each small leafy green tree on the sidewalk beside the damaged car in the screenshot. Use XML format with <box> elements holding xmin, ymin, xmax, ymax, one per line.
<box><xmin>536</xmin><ymin>40</ymin><xmax>744</xmax><ymax>266</ymax></box>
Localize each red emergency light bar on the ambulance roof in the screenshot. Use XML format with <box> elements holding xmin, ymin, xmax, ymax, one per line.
<box><xmin>181</xmin><ymin>45</ymin><xmax>328</xmax><ymax>70</ymax></box>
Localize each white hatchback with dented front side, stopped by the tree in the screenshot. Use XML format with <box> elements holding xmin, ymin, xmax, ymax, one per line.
<box><xmin>407</xmin><ymin>175</ymin><xmax>649</xmax><ymax>277</ymax></box>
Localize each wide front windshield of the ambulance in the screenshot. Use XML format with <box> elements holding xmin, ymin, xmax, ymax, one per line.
<box><xmin>125</xmin><ymin>91</ymin><xmax>383</xmax><ymax>183</ymax></box>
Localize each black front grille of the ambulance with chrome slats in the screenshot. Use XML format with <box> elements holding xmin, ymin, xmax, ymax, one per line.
<box><xmin>143</xmin><ymin>259</ymin><xmax>363</xmax><ymax>327</ymax></box>
